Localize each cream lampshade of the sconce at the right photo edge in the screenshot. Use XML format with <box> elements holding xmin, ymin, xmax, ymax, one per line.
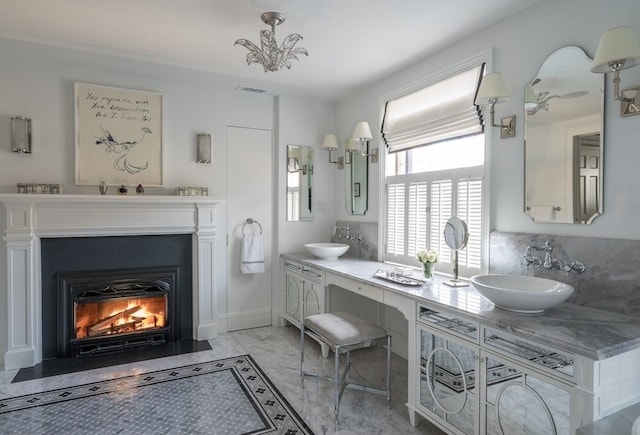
<box><xmin>591</xmin><ymin>26</ymin><xmax>640</xmax><ymax>73</ymax></box>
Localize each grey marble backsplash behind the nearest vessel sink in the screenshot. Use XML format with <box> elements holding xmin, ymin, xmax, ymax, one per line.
<box><xmin>489</xmin><ymin>231</ymin><xmax>640</xmax><ymax>317</ymax></box>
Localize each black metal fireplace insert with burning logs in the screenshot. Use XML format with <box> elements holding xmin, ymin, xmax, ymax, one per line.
<box><xmin>56</xmin><ymin>267</ymin><xmax>182</xmax><ymax>358</ymax></box>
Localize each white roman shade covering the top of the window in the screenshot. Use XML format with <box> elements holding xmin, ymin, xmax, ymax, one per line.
<box><xmin>382</xmin><ymin>64</ymin><xmax>484</xmax><ymax>153</ymax></box>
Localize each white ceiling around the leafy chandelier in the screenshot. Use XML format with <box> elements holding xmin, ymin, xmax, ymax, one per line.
<box><xmin>0</xmin><ymin>0</ymin><xmax>540</xmax><ymax>99</ymax></box>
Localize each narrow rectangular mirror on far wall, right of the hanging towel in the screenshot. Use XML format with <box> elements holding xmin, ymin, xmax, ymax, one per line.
<box><xmin>287</xmin><ymin>145</ymin><xmax>313</xmax><ymax>221</ymax></box>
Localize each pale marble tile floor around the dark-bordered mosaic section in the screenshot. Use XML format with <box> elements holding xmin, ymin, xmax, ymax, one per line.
<box><xmin>0</xmin><ymin>326</ymin><xmax>443</xmax><ymax>435</ymax></box>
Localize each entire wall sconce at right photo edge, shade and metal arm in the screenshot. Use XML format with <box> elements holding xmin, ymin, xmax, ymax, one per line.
<box><xmin>591</xmin><ymin>26</ymin><xmax>640</xmax><ymax>116</ymax></box>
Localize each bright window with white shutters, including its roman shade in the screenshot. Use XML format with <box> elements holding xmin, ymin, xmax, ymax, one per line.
<box><xmin>382</xmin><ymin>59</ymin><xmax>485</xmax><ymax>276</ymax></box>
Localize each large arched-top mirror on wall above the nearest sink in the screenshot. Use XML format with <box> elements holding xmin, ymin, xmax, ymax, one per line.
<box><xmin>524</xmin><ymin>46</ymin><xmax>604</xmax><ymax>224</ymax></box>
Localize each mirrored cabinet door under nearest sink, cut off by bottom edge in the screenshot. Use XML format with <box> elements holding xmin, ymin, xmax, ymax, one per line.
<box><xmin>483</xmin><ymin>355</ymin><xmax>571</xmax><ymax>435</ymax></box>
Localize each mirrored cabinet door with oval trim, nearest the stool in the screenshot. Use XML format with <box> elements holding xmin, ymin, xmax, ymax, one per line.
<box><xmin>419</xmin><ymin>328</ymin><xmax>478</xmax><ymax>434</ymax></box>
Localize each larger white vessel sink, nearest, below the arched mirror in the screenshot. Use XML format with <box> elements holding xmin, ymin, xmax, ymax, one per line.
<box><xmin>471</xmin><ymin>275</ymin><xmax>573</xmax><ymax>313</ymax></box>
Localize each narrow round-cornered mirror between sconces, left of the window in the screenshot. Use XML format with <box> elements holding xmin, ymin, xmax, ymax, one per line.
<box><xmin>344</xmin><ymin>139</ymin><xmax>369</xmax><ymax>216</ymax></box>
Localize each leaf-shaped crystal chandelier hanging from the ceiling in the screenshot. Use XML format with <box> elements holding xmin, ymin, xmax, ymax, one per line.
<box><xmin>233</xmin><ymin>12</ymin><xmax>309</xmax><ymax>72</ymax></box>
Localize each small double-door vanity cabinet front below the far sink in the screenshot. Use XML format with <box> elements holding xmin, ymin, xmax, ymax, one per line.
<box><xmin>283</xmin><ymin>260</ymin><xmax>324</xmax><ymax>328</ymax></box>
